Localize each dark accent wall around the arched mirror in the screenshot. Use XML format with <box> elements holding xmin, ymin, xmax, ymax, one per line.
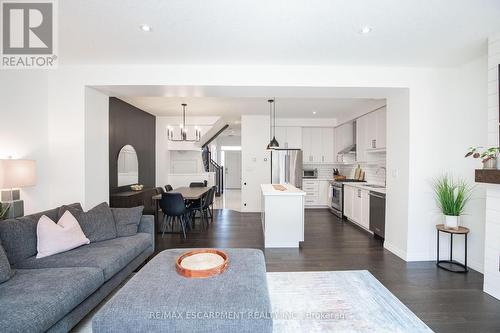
<box><xmin>109</xmin><ymin>97</ymin><xmax>156</xmax><ymax>194</ymax></box>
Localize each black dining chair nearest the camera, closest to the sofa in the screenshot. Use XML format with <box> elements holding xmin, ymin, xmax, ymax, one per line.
<box><xmin>160</xmin><ymin>192</ymin><xmax>189</xmax><ymax>238</ymax></box>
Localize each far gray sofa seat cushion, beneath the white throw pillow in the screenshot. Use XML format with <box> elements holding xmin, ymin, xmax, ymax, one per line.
<box><xmin>15</xmin><ymin>233</ymin><xmax>152</xmax><ymax>281</ymax></box>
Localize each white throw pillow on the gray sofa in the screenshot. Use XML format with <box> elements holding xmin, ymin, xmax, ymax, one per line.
<box><xmin>36</xmin><ymin>211</ymin><xmax>90</xmax><ymax>258</ymax></box>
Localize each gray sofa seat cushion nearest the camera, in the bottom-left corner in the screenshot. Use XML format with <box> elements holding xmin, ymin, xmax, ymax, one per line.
<box><xmin>0</xmin><ymin>267</ymin><xmax>104</xmax><ymax>332</ymax></box>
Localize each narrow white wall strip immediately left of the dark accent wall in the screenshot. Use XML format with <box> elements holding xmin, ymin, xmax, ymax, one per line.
<box><xmin>83</xmin><ymin>88</ymin><xmax>109</xmax><ymax>209</ymax></box>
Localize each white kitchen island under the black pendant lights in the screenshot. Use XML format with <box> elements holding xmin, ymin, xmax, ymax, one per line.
<box><xmin>261</xmin><ymin>184</ymin><xmax>306</xmax><ymax>248</ymax></box>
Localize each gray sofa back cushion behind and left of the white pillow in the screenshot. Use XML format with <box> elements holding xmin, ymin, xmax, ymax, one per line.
<box><xmin>0</xmin><ymin>203</ymin><xmax>82</xmax><ymax>265</ymax></box>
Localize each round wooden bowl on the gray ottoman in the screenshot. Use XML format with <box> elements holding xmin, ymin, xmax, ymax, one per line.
<box><xmin>175</xmin><ymin>249</ymin><xmax>228</xmax><ymax>278</ymax></box>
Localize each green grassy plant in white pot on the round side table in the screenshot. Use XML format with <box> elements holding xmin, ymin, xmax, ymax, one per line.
<box><xmin>434</xmin><ymin>175</ymin><xmax>472</xmax><ymax>229</ymax></box>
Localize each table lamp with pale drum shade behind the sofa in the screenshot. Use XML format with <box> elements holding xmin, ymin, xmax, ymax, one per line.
<box><xmin>0</xmin><ymin>159</ymin><xmax>36</xmax><ymax>218</ymax></box>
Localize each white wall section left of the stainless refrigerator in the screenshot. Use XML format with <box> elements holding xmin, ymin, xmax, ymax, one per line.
<box><xmin>241</xmin><ymin>115</ymin><xmax>271</xmax><ymax>212</ymax></box>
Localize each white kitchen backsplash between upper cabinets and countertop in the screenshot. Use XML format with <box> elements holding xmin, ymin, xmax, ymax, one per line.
<box><xmin>304</xmin><ymin>162</ymin><xmax>386</xmax><ymax>184</ymax></box>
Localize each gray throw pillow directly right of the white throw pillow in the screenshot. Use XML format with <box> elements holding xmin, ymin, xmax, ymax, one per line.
<box><xmin>60</xmin><ymin>202</ymin><xmax>116</xmax><ymax>243</ymax></box>
